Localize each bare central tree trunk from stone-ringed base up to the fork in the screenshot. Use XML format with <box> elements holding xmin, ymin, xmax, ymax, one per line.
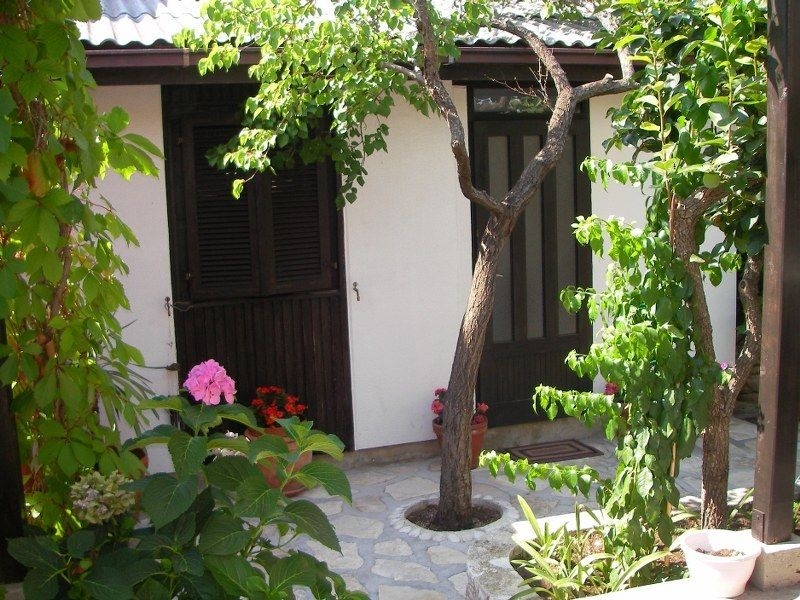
<box><xmin>435</xmin><ymin>215</ymin><xmax>516</xmax><ymax>531</ymax></box>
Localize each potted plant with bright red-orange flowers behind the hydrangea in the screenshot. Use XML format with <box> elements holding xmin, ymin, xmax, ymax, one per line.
<box><xmin>244</xmin><ymin>385</ymin><xmax>312</xmax><ymax>497</ymax></box>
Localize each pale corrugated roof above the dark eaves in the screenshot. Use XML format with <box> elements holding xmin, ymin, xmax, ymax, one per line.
<box><xmin>78</xmin><ymin>0</ymin><xmax>596</xmax><ymax>47</ymax></box>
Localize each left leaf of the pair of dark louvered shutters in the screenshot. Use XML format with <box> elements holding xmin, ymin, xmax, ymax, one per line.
<box><xmin>184</xmin><ymin>121</ymin><xmax>261</xmax><ymax>300</ymax></box>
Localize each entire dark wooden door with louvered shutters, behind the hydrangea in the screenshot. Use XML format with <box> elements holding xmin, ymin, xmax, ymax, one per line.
<box><xmin>163</xmin><ymin>85</ymin><xmax>353</xmax><ymax>447</ymax></box>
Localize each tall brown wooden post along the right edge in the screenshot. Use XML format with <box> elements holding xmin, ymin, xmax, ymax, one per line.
<box><xmin>753</xmin><ymin>0</ymin><xmax>800</xmax><ymax>544</ymax></box>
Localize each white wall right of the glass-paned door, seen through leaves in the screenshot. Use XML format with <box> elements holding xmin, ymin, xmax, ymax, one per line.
<box><xmin>589</xmin><ymin>96</ymin><xmax>736</xmax><ymax>391</ymax></box>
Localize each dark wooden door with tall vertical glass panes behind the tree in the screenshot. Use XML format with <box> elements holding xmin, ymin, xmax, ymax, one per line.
<box><xmin>472</xmin><ymin>117</ymin><xmax>591</xmax><ymax>425</ymax></box>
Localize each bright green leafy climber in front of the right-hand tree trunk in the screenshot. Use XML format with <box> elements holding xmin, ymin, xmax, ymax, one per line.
<box><xmin>485</xmin><ymin>217</ymin><xmax>724</xmax><ymax>563</ymax></box>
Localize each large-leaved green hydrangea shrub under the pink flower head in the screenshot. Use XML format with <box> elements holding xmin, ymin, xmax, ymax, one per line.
<box><xmin>9</xmin><ymin>396</ymin><xmax>366</xmax><ymax>600</ymax></box>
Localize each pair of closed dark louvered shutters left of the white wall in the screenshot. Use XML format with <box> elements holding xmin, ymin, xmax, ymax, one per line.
<box><xmin>184</xmin><ymin>119</ymin><xmax>336</xmax><ymax>301</ymax></box>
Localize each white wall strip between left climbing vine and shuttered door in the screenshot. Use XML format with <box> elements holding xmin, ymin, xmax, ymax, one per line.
<box><xmin>94</xmin><ymin>85</ymin><xmax>178</xmax><ymax>471</ymax></box>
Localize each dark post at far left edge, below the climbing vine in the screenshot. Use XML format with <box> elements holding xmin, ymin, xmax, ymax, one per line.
<box><xmin>0</xmin><ymin>319</ymin><xmax>25</xmax><ymax>583</ymax></box>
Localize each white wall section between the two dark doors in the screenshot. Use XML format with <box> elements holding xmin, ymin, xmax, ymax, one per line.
<box><xmin>344</xmin><ymin>87</ymin><xmax>472</xmax><ymax>449</ymax></box>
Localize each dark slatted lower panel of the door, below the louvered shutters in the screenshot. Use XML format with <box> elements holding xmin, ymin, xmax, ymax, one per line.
<box><xmin>175</xmin><ymin>293</ymin><xmax>352</xmax><ymax>440</ymax></box>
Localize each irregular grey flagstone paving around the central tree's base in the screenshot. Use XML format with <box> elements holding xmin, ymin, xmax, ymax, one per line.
<box><xmin>297</xmin><ymin>419</ymin><xmax>800</xmax><ymax>600</ymax></box>
